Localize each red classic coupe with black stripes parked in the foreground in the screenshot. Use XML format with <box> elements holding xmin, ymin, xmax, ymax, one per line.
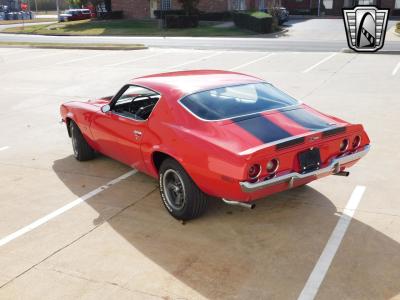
<box><xmin>61</xmin><ymin>70</ymin><xmax>370</xmax><ymax>220</ymax></box>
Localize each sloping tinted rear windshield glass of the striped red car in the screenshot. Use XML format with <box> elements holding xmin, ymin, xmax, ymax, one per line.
<box><xmin>181</xmin><ymin>83</ymin><xmax>299</xmax><ymax>121</ymax></box>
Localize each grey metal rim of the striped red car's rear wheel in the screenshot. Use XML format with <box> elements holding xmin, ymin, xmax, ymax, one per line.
<box><xmin>163</xmin><ymin>169</ymin><xmax>186</xmax><ymax>210</ymax></box>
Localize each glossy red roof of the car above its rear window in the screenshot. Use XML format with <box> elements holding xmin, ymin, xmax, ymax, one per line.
<box><xmin>130</xmin><ymin>70</ymin><xmax>263</xmax><ymax>98</ymax></box>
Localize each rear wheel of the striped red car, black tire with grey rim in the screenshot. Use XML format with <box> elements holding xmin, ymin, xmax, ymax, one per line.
<box><xmin>159</xmin><ymin>158</ymin><xmax>208</xmax><ymax>221</ymax></box>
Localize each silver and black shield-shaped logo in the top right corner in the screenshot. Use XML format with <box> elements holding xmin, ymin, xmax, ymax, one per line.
<box><xmin>343</xmin><ymin>6</ymin><xmax>389</xmax><ymax>52</ymax></box>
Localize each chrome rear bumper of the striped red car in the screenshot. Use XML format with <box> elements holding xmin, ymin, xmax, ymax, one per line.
<box><xmin>240</xmin><ymin>145</ymin><xmax>370</xmax><ymax>193</ymax></box>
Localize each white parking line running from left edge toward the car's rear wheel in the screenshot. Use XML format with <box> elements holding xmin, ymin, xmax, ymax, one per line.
<box><xmin>0</xmin><ymin>170</ymin><xmax>137</xmax><ymax>247</ymax></box>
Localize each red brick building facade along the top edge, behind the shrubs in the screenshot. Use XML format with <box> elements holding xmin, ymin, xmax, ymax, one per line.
<box><xmin>111</xmin><ymin>0</ymin><xmax>400</xmax><ymax>19</ymax></box>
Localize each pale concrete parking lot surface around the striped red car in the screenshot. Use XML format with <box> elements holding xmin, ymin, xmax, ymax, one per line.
<box><xmin>0</xmin><ymin>48</ymin><xmax>400</xmax><ymax>299</ymax></box>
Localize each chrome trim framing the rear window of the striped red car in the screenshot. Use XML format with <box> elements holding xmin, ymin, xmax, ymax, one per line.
<box><xmin>178</xmin><ymin>81</ymin><xmax>303</xmax><ymax>122</ymax></box>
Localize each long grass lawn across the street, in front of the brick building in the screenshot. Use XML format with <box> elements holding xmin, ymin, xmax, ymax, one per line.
<box><xmin>2</xmin><ymin>20</ymin><xmax>255</xmax><ymax>36</ymax></box>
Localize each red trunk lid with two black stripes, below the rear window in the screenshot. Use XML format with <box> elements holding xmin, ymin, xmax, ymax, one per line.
<box><xmin>214</xmin><ymin>105</ymin><xmax>348</xmax><ymax>155</ymax></box>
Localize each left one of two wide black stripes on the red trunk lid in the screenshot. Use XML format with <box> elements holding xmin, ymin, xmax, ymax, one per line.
<box><xmin>232</xmin><ymin>114</ymin><xmax>292</xmax><ymax>143</ymax></box>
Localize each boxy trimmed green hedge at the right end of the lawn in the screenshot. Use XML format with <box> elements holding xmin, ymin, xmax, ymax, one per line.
<box><xmin>233</xmin><ymin>12</ymin><xmax>273</xmax><ymax>33</ymax></box>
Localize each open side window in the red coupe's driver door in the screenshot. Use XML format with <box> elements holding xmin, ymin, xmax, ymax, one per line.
<box><xmin>112</xmin><ymin>85</ymin><xmax>161</xmax><ymax>121</ymax></box>
